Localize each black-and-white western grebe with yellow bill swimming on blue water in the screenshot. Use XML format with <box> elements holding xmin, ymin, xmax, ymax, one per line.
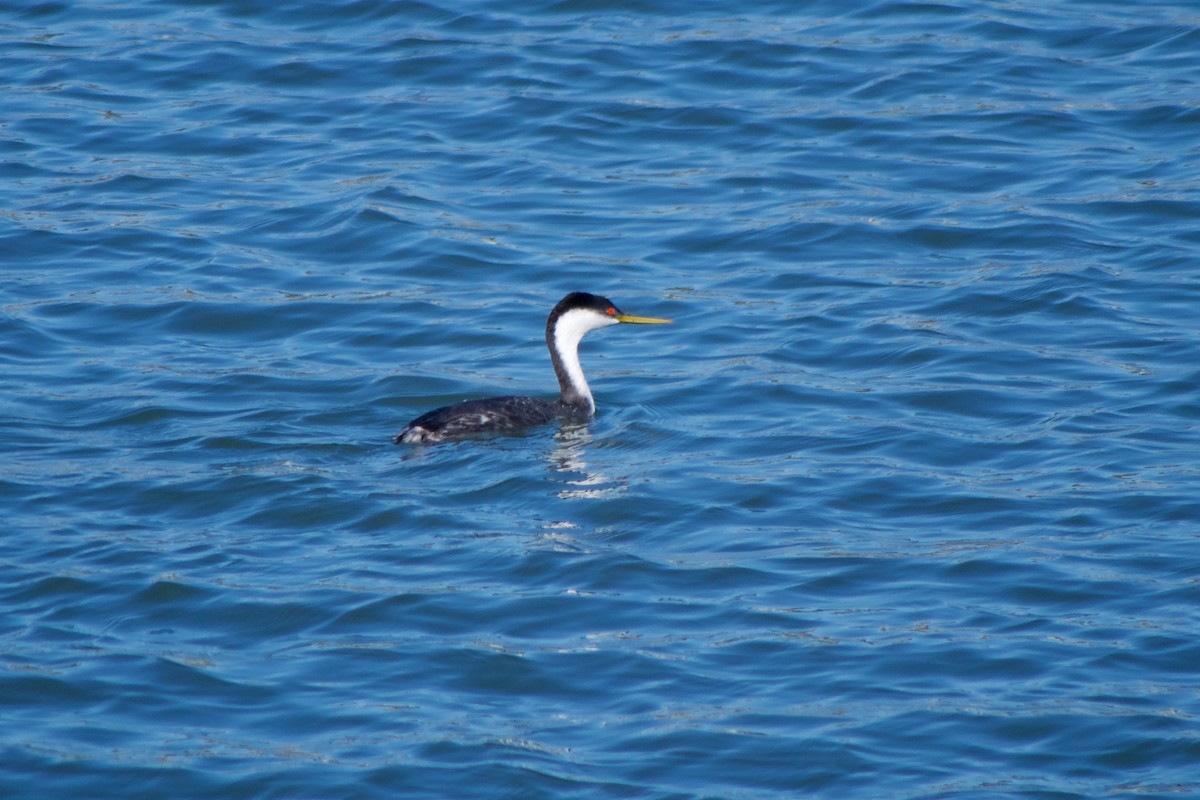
<box><xmin>394</xmin><ymin>291</ymin><xmax>671</xmax><ymax>444</ymax></box>
